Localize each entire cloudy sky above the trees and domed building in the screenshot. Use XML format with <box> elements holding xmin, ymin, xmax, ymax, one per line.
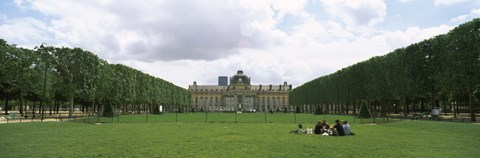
<box><xmin>0</xmin><ymin>0</ymin><xmax>480</xmax><ymax>88</ymax></box>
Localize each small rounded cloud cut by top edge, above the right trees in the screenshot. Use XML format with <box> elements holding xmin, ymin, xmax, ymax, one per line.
<box><xmin>322</xmin><ymin>0</ymin><xmax>387</xmax><ymax>27</ymax></box>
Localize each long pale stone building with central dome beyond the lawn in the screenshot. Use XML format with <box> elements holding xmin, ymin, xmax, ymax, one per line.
<box><xmin>188</xmin><ymin>70</ymin><xmax>293</xmax><ymax>112</ymax></box>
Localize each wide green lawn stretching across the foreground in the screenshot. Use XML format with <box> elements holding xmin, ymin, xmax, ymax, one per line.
<box><xmin>0</xmin><ymin>114</ymin><xmax>480</xmax><ymax>157</ymax></box>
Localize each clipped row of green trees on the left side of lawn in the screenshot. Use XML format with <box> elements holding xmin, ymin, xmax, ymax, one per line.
<box><xmin>0</xmin><ymin>39</ymin><xmax>190</xmax><ymax>116</ymax></box>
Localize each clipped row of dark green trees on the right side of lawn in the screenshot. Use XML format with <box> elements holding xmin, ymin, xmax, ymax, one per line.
<box><xmin>289</xmin><ymin>19</ymin><xmax>480</xmax><ymax>121</ymax></box>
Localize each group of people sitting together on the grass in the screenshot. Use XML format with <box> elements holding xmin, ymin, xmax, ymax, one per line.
<box><xmin>290</xmin><ymin>119</ymin><xmax>355</xmax><ymax>136</ymax></box>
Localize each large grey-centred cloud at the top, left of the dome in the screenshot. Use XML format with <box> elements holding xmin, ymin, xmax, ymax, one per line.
<box><xmin>104</xmin><ymin>1</ymin><xmax>265</xmax><ymax>61</ymax></box>
